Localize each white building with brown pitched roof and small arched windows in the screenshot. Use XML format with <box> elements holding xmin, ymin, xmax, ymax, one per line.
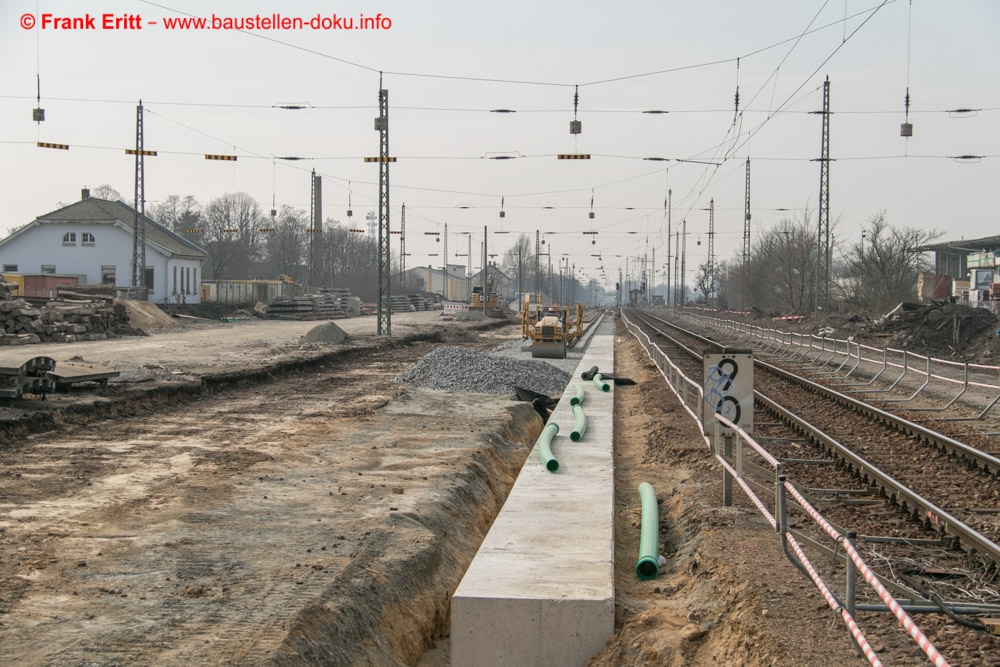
<box><xmin>0</xmin><ymin>190</ymin><xmax>208</xmax><ymax>303</ymax></box>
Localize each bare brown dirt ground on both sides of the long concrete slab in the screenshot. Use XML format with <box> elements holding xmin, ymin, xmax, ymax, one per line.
<box><xmin>0</xmin><ymin>313</ymin><xmax>978</xmax><ymax>666</ymax></box>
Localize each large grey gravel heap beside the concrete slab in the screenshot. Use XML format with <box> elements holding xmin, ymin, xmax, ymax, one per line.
<box><xmin>393</xmin><ymin>347</ymin><xmax>570</xmax><ymax>396</ymax></box>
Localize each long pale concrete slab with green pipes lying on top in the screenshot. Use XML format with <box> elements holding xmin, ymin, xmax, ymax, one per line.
<box><xmin>451</xmin><ymin>333</ymin><xmax>615</xmax><ymax>667</ymax></box>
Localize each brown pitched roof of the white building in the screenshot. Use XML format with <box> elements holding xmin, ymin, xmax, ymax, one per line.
<box><xmin>0</xmin><ymin>197</ymin><xmax>208</xmax><ymax>260</ymax></box>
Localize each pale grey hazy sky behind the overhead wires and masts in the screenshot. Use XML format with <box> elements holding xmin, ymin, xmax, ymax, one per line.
<box><xmin>0</xmin><ymin>0</ymin><xmax>1000</xmax><ymax>285</ymax></box>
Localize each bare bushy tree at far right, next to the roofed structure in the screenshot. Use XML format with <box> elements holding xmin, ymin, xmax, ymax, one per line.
<box><xmin>844</xmin><ymin>211</ymin><xmax>942</xmax><ymax>317</ymax></box>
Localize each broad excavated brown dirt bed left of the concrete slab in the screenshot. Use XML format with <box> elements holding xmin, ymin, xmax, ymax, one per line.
<box><xmin>0</xmin><ymin>325</ymin><xmax>541</xmax><ymax>665</ymax></box>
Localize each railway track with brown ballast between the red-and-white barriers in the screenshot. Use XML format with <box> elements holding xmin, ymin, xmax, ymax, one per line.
<box><xmin>626</xmin><ymin>311</ymin><xmax>1000</xmax><ymax>628</ymax></box>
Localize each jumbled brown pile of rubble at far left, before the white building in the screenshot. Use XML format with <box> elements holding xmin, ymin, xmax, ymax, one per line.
<box><xmin>0</xmin><ymin>282</ymin><xmax>115</xmax><ymax>345</ymax></box>
